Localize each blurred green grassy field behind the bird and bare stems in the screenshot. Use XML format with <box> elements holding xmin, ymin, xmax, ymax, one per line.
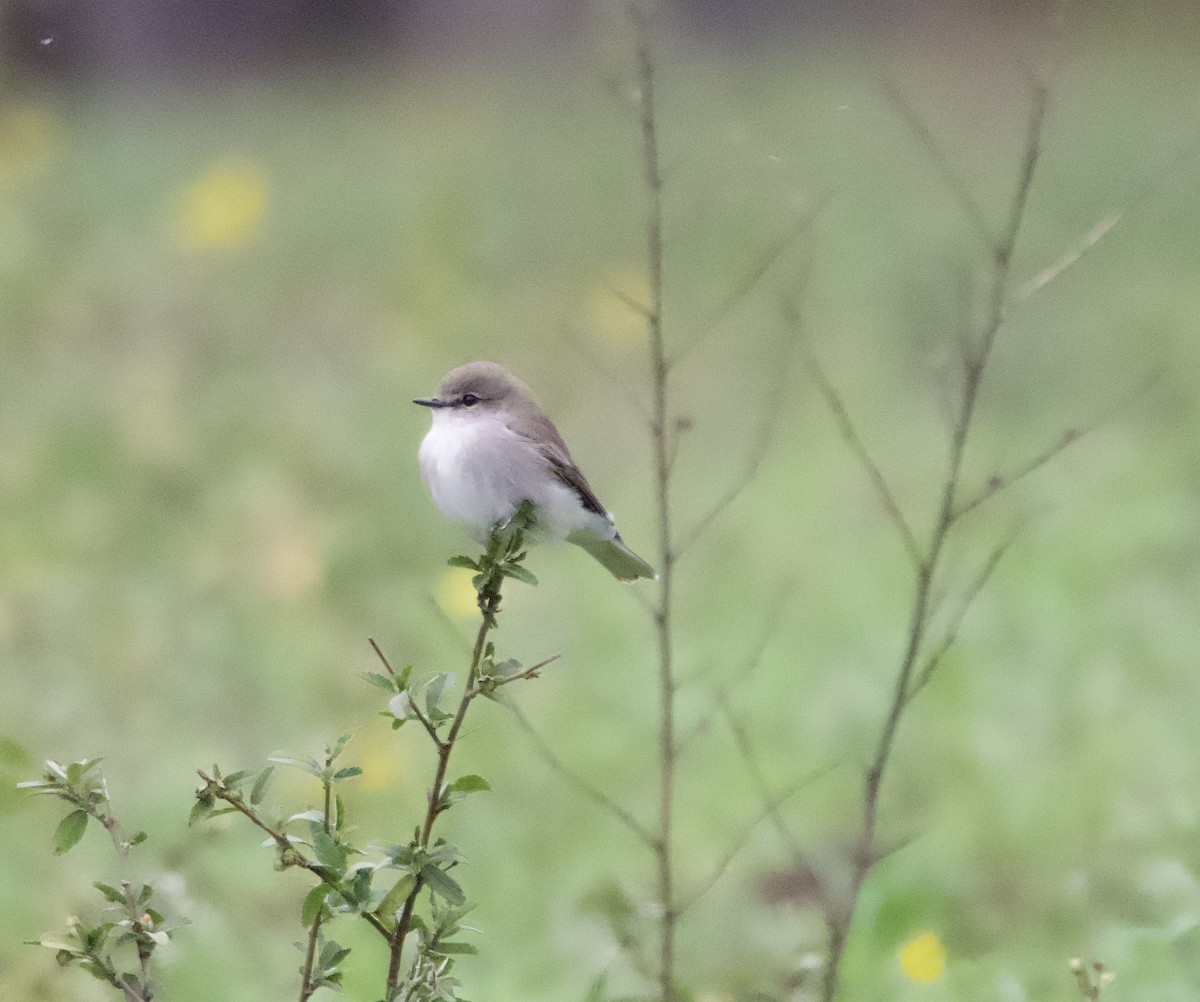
<box><xmin>0</xmin><ymin>4</ymin><xmax>1200</xmax><ymax>1002</ymax></box>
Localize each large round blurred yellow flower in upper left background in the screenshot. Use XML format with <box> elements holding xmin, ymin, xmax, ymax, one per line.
<box><xmin>174</xmin><ymin>161</ymin><xmax>266</xmax><ymax>250</ymax></box>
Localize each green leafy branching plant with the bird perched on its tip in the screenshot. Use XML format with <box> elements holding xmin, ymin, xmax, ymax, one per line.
<box><xmin>191</xmin><ymin>503</ymin><xmax>557</xmax><ymax>1002</ymax></box>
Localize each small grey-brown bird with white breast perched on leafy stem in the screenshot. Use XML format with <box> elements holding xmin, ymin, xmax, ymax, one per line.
<box><xmin>413</xmin><ymin>362</ymin><xmax>658</xmax><ymax>581</ymax></box>
